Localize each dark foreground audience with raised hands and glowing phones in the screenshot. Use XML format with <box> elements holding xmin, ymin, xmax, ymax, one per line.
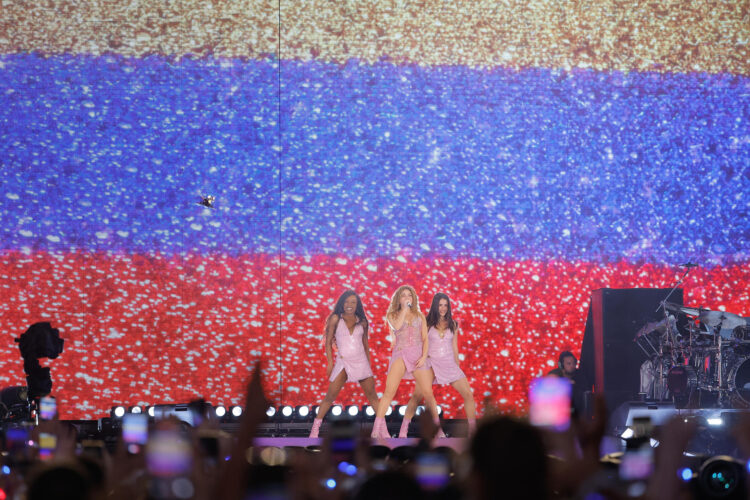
<box><xmin>0</xmin><ymin>363</ymin><xmax>750</xmax><ymax>500</ymax></box>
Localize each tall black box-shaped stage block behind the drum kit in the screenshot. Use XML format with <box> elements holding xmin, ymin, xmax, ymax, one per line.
<box><xmin>580</xmin><ymin>288</ymin><xmax>683</xmax><ymax>411</ymax></box>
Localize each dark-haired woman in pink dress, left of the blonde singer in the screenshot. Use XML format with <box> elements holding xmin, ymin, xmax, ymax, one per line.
<box><xmin>310</xmin><ymin>290</ymin><xmax>378</xmax><ymax>438</ymax></box>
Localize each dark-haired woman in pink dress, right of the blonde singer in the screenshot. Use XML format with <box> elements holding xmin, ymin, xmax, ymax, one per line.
<box><xmin>398</xmin><ymin>293</ymin><xmax>477</xmax><ymax>437</ymax></box>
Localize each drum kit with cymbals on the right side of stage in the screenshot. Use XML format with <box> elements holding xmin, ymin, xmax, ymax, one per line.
<box><xmin>635</xmin><ymin>301</ymin><xmax>750</xmax><ymax>408</ymax></box>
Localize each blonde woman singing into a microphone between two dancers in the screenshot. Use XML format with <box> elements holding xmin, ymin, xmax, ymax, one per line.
<box><xmin>372</xmin><ymin>285</ymin><xmax>445</xmax><ymax>438</ymax></box>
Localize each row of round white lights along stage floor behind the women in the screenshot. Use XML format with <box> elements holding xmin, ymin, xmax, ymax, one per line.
<box><xmin>110</xmin><ymin>405</ymin><xmax>443</xmax><ymax>422</ymax></box>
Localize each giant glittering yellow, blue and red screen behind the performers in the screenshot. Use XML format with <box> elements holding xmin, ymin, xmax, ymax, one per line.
<box><xmin>0</xmin><ymin>0</ymin><xmax>750</xmax><ymax>418</ymax></box>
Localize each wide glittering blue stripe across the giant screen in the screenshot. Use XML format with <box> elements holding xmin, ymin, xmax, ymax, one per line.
<box><xmin>0</xmin><ymin>54</ymin><xmax>750</xmax><ymax>263</ymax></box>
